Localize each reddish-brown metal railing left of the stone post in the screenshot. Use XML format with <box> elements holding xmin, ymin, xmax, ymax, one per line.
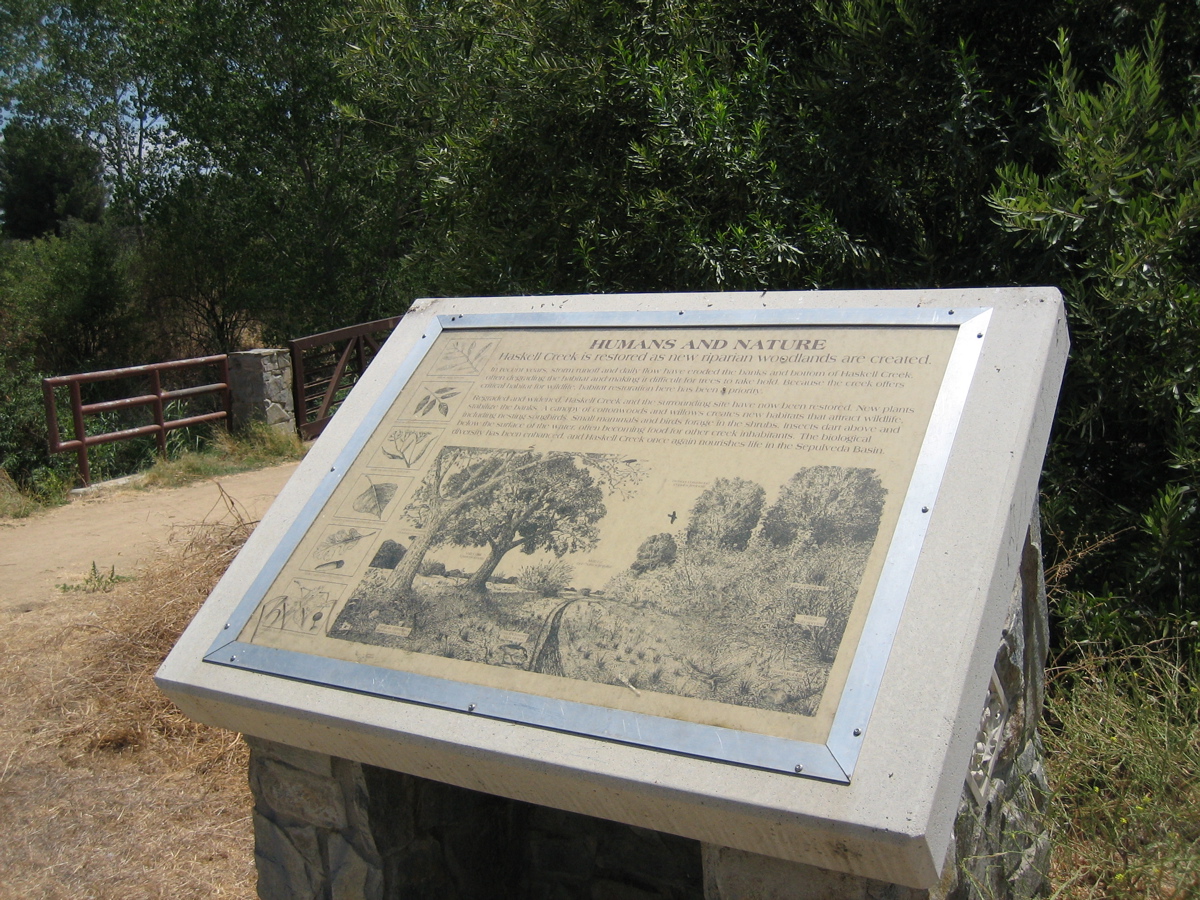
<box><xmin>42</xmin><ymin>354</ymin><xmax>232</xmax><ymax>485</ymax></box>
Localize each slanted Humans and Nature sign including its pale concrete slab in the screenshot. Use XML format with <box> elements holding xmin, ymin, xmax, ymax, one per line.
<box><xmin>160</xmin><ymin>292</ymin><xmax>1066</xmax><ymax>883</ymax></box>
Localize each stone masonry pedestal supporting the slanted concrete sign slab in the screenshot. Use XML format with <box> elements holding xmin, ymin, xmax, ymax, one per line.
<box><xmin>247</xmin><ymin>512</ymin><xmax>1050</xmax><ymax>900</ymax></box>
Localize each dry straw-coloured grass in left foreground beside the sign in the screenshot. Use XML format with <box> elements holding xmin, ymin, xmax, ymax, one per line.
<box><xmin>0</xmin><ymin>508</ymin><xmax>254</xmax><ymax>900</ymax></box>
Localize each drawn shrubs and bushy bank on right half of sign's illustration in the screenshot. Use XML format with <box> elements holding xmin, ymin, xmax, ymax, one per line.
<box><xmin>586</xmin><ymin>467</ymin><xmax>886</xmax><ymax>715</ymax></box>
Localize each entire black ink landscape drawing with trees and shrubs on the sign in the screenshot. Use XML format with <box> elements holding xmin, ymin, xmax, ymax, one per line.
<box><xmin>329</xmin><ymin>446</ymin><xmax>886</xmax><ymax>715</ymax></box>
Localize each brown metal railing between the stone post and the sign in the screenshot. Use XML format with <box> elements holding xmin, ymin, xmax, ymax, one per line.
<box><xmin>288</xmin><ymin>316</ymin><xmax>401</xmax><ymax>440</ymax></box>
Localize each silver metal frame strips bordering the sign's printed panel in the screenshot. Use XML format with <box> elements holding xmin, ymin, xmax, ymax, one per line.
<box><xmin>205</xmin><ymin>307</ymin><xmax>991</xmax><ymax>784</ymax></box>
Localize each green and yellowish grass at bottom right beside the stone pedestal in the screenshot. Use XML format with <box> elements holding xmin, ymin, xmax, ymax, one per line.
<box><xmin>1044</xmin><ymin>641</ymin><xmax>1200</xmax><ymax>900</ymax></box>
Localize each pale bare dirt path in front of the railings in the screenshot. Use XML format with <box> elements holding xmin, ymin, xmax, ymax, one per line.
<box><xmin>0</xmin><ymin>463</ymin><xmax>296</xmax><ymax>618</ymax></box>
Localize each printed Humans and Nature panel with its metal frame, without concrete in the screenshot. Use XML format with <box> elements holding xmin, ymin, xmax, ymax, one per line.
<box><xmin>208</xmin><ymin>310</ymin><xmax>989</xmax><ymax>781</ymax></box>
